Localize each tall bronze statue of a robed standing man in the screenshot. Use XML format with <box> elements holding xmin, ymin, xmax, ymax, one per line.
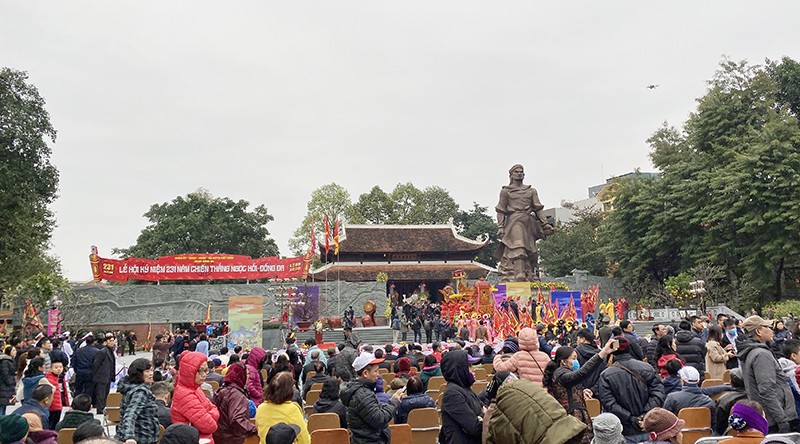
<box><xmin>495</xmin><ymin>164</ymin><xmax>553</xmax><ymax>282</ymax></box>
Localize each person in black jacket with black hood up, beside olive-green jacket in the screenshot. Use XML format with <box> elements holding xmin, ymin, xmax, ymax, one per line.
<box><xmin>440</xmin><ymin>350</ymin><xmax>482</xmax><ymax>444</ymax></box>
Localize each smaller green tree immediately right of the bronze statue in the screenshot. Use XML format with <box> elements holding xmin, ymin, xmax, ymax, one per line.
<box><xmin>537</xmin><ymin>209</ymin><xmax>607</xmax><ymax>276</ymax></box>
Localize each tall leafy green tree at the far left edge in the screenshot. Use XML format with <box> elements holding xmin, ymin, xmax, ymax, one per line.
<box><xmin>0</xmin><ymin>68</ymin><xmax>58</xmax><ymax>302</ymax></box>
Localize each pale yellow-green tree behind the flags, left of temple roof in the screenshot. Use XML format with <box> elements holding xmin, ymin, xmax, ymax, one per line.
<box><xmin>289</xmin><ymin>183</ymin><xmax>353</xmax><ymax>256</ymax></box>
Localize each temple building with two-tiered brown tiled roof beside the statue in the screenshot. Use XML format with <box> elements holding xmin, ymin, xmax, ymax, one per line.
<box><xmin>310</xmin><ymin>225</ymin><xmax>497</xmax><ymax>298</ymax></box>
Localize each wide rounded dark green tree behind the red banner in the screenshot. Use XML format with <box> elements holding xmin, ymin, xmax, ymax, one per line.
<box><xmin>114</xmin><ymin>189</ymin><xmax>278</xmax><ymax>258</ymax></box>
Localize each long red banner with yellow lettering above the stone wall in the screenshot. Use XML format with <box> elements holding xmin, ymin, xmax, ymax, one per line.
<box><xmin>89</xmin><ymin>251</ymin><xmax>311</xmax><ymax>282</ymax></box>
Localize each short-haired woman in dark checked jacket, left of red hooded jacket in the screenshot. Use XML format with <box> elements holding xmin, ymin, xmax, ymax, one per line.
<box><xmin>116</xmin><ymin>358</ymin><xmax>160</xmax><ymax>444</ymax></box>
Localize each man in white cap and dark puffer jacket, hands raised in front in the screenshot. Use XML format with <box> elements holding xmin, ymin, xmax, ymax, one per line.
<box><xmin>341</xmin><ymin>352</ymin><xmax>405</xmax><ymax>444</ymax></box>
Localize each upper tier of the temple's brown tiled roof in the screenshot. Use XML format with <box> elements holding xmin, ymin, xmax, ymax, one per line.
<box><xmin>332</xmin><ymin>225</ymin><xmax>486</xmax><ymax>254</ymax></box>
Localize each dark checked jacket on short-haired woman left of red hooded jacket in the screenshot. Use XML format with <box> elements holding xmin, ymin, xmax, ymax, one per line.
<box><xmin>116</xmin><ymin>378</ymin><xmax>159</xmax><ymax>444</ymax></box>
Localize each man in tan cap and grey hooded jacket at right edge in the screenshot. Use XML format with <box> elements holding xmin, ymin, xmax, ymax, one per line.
<box><xmin>739</xmin><ymin>316</ymin><xmax>797</xmax><ymax>433</ymax></box>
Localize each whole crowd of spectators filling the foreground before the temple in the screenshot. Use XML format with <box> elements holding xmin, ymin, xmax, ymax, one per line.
<box><xmin>0</xmin><ymin>312</ymin><xmax>800</xmax><ymax>444</ymax></box>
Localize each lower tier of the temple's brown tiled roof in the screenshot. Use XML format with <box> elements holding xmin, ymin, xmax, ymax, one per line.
<box><xmin>311</xmin><ymin>262</ymin><xmax>496</xmax><ymax>282</ymax></box>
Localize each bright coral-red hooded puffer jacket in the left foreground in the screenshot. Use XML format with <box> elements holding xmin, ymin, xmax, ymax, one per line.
<box><xmin>170</xmin><ymin>352</ymin><xmax>219</xmax><ymax>443</ymax></box>
